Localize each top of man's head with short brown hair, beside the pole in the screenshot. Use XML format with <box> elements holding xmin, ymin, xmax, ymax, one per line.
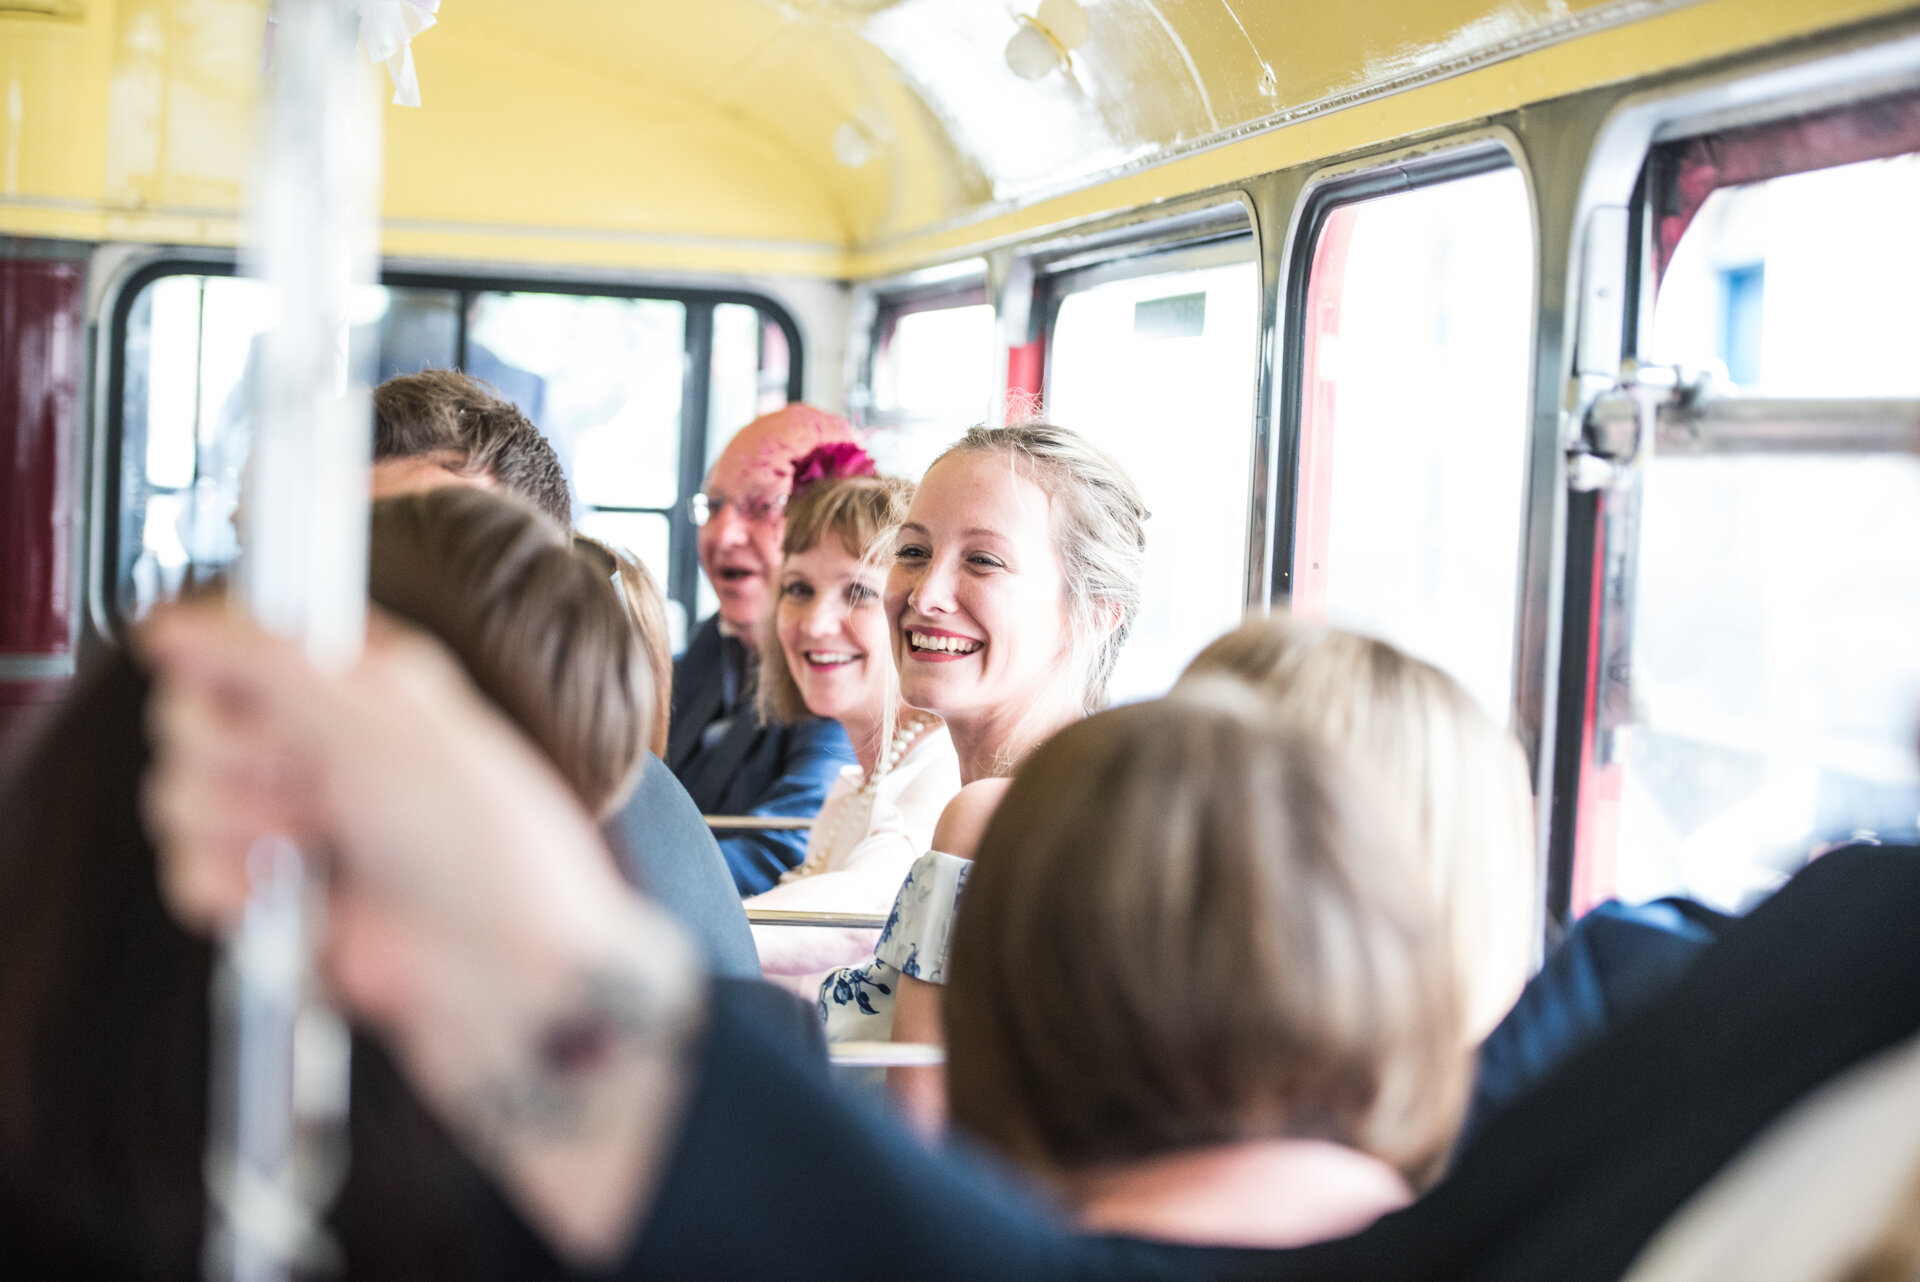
<box><xmin>372</xmin><ymin>368</ymin><xmax>574</xmax><ymax>528</ymax></box>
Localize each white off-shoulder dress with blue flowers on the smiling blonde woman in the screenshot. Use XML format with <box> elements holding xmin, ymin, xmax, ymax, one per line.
<box><xmin>820</xmin><ymin>850</ymin><xmax>973</xmax><ymax>1042</ymax></box>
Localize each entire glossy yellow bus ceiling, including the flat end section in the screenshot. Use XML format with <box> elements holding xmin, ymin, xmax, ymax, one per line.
<box><xmin>0</xmin><ymin>0</ymin><xmax>1899</xmax><ymax>276</ymax></box>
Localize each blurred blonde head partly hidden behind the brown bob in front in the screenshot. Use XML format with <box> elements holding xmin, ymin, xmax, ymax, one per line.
<box><xmin>1181</xmin><ymin>616</ymin><xmax>1540</xmax><ymax>1044</ymax></box>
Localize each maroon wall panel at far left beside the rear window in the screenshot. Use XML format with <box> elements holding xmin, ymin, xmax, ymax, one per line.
<box><xmin>0</xmin><ymin>259</ymin><xmax>84</xmax><ymax>654</ymax></box>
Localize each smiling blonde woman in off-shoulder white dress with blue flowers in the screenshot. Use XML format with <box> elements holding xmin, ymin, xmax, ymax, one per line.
<box><xmin>820</xmin><ymin>422</ymin><xmax>1148</xmax><ymax>1128</ymax></box>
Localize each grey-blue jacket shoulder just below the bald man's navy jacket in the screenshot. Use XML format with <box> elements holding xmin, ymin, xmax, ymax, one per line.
<box><xmin>607</xmin><ymin>752</ymin><xmax>760</xmax><ymax>979</ymax></box>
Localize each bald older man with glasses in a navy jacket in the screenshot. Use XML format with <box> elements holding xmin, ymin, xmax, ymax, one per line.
<box><xmin>666</xmin><ymin>405</ymin><xmax>854</xmax><ymax>894</ymax></box>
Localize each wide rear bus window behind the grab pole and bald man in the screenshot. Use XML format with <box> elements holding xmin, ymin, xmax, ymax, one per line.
<box><xmin>106</xmin><ymin>271</ymin><xmax>799</xmax><ymax>637</ymax></box>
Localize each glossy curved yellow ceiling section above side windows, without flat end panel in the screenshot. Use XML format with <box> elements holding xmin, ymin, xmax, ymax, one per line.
<box><xmin>445</xmin><ymin>0</ymin><xmax>1684</xmax><ymax>246</ymax></box>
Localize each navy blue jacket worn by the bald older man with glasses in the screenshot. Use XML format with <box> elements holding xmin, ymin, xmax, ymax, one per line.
<box><xmin>666</xmin><ymin>616</ymin><xmax>854</xmax><ymax>894</ymax></box>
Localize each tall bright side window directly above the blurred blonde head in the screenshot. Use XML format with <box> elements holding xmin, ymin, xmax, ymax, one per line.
<box><xmin>1290</xmin><ymin>167</ymin><xmax>1534</xmax><ymax>722</ymax></box>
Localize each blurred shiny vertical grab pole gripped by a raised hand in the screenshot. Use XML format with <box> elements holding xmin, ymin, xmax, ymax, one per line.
<box><xmin>204</xmin><ymin>0</ymin><xmax>380</xmax><ymax>1282</ymax></box>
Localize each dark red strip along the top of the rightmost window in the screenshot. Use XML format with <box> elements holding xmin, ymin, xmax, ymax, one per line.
<box><xmin>1659</xmin><ymin>94</ymin><xmax>1920</xmax><ymax>274</ymax></box>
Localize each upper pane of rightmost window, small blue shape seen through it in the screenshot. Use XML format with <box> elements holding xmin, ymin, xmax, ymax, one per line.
<box><xmin>1645</xmin><ymin>155</ymin><xmax>1920</xmax><ymax>395</ymax></box>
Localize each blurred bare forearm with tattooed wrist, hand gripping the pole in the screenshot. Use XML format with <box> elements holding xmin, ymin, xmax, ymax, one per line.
<box><xmin>146</xmin><ymin>606</ymin><xmax>705</xmax><ymax>1261</ymax></box>
